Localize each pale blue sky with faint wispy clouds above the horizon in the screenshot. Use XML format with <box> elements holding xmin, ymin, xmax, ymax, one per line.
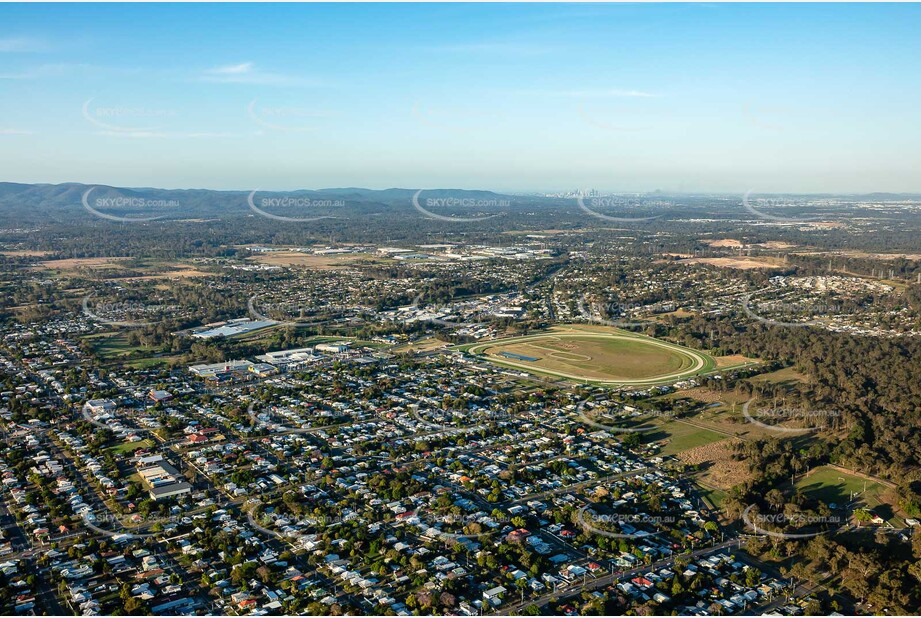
<box><xmin>0</xmin><ymin>4</ymin><xmax>921</xmax><ymax>192</ymax></box>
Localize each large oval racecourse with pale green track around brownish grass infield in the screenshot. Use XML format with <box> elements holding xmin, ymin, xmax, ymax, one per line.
<box><xmin>465</xmin><ymin>329</ymin><xmax>716</xmax><ymax>386</ymax></box>
